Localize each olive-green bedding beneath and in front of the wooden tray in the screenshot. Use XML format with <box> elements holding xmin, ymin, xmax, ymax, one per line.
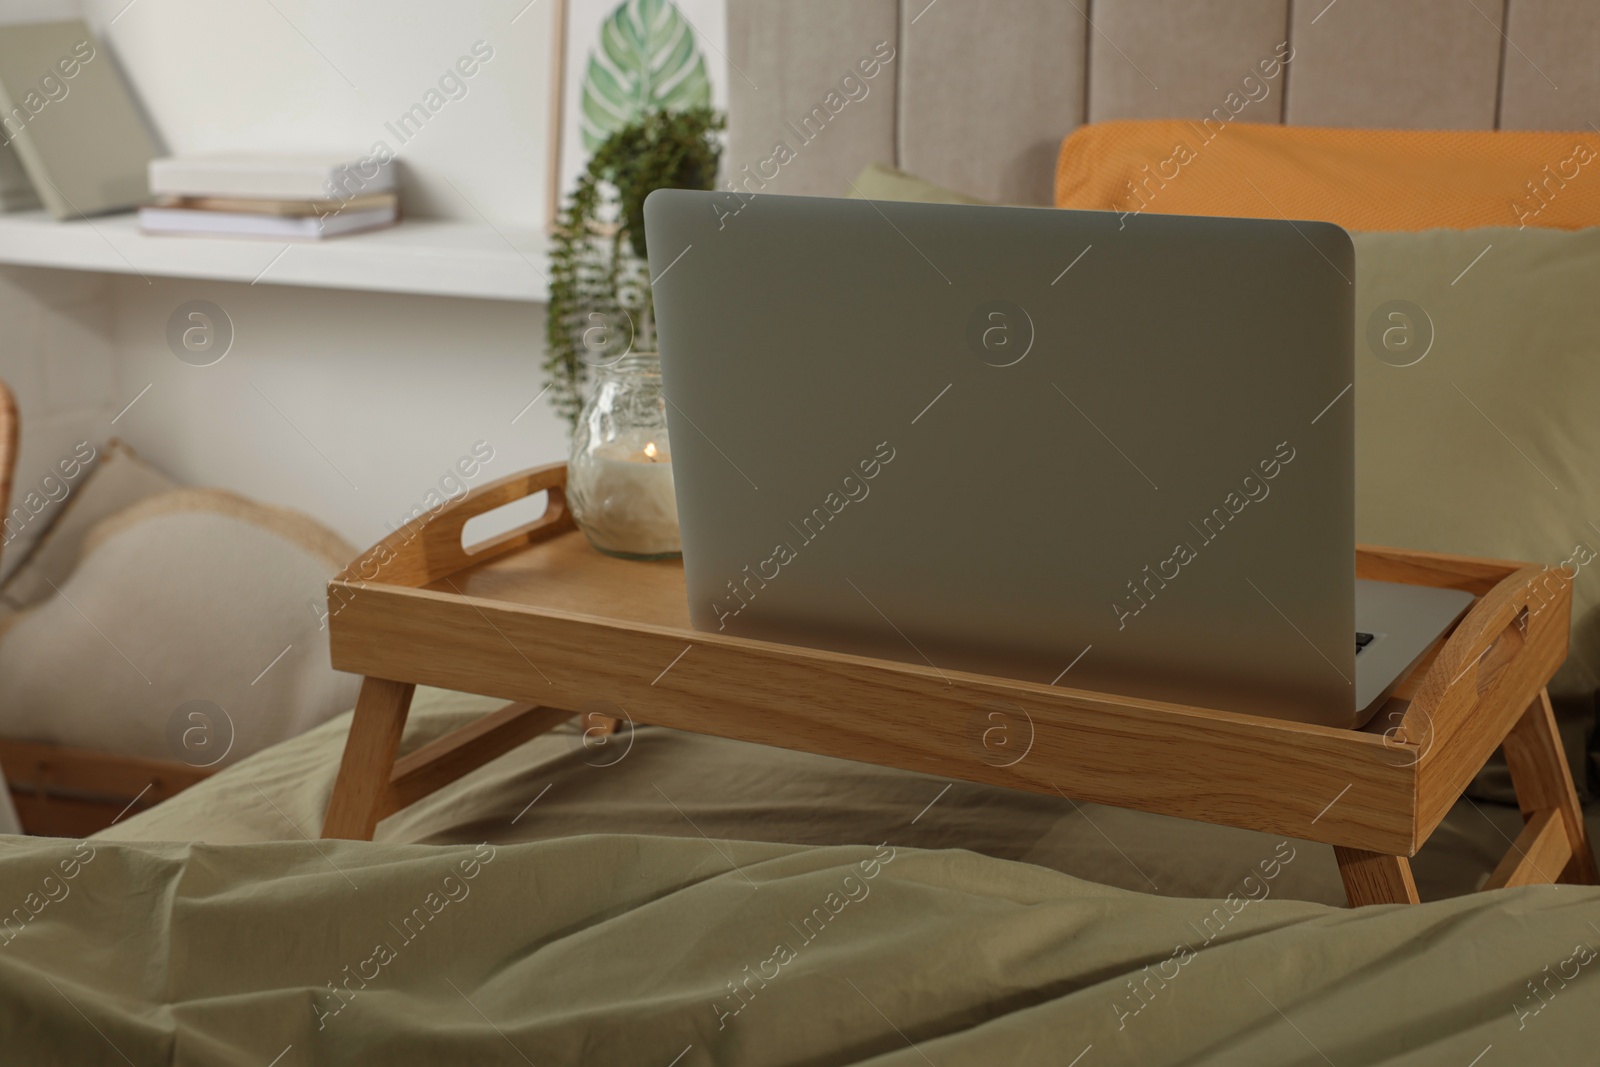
<box><xmin>0</xmin><ymin>691</ymin><xmax>1600</xmax><ymax>1065</ymax></box>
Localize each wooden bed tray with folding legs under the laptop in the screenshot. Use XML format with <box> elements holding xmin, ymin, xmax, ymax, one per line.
<box><xmin>323</xmin><ymin>464</ymin><xmax>1597</xmax><ymax>904</ymax></box>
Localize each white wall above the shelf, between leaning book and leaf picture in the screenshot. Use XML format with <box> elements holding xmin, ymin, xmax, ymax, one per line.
<box><xmin>82</xmin><ymin>0</ymin><xmax>555</xmax><ymax>226</ymax></box>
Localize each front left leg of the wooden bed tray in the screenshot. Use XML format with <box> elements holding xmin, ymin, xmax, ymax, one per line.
<box><xmin>322</xmin><ymin>678</ymin><xmax>416</xmax><ymax>841</ymax></box>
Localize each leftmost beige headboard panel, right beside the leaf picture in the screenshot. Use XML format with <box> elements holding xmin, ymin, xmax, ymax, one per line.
<box><xmin>722</xmin><ymin>0</ymin><xmax>902</xmax><ymax>197</ymax></box>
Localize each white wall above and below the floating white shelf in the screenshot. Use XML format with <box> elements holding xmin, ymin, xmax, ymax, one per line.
<box><xmin>0</xmin><ymin>0</ymin><xmax>566</xmax><ymax>550</ymax></box>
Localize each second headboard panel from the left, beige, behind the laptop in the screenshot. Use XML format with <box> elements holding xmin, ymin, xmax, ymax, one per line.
<box><xmin>902</xmin><ymin>0</ymin><xmax>1086</xmax><ymax>203</ymax></box>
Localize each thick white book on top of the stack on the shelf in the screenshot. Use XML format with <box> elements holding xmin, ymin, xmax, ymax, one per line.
<box><xmin>150</xmin><ymin>152</ymin><xmax>395</xmax><ymax>200</ymax></box>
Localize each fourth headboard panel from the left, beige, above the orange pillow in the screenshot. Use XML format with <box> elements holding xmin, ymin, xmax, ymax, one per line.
<box><xmin>1286</xmin><ymin>0</ymin><xmax>1504</xmax><ymax>130</ymax></box>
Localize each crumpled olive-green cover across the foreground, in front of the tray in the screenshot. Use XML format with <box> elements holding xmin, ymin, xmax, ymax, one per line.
<box><xmin>0</xmin><ymin>835</ymin><xmax>1600</xmax><ymax>1067</ymax></box>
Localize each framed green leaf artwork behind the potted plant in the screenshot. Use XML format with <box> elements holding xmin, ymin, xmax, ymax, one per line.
<box><xmin>546</xmin><ymin>0</ymin><xmax>728</xmax><ymax>224</ymax></box>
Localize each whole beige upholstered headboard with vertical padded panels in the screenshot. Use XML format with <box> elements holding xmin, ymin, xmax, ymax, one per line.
<box><xmin>726</xmin><ymin>0</ymin><xmax>1600</xmax><ymax>203</ymax></box>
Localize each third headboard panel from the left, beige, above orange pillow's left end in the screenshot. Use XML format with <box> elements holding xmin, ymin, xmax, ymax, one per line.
<box><xmin>1086</xmin><ymin>0</ymin><xmax>1290</xmax><ymax>122</ymax></box>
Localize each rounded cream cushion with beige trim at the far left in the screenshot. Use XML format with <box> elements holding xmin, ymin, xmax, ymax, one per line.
<box><xmin>0</xmin><ymin>490</ymin><xmax>358</xmax><ymax>766</ymax></box>
